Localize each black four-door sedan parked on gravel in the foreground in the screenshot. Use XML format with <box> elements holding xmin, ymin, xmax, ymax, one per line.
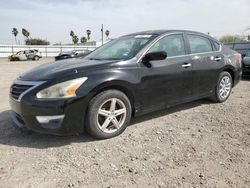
<box><xmin>10</xmin><ymin>30</ymin><xmax>241</xmax><ymax>139</ymax></box>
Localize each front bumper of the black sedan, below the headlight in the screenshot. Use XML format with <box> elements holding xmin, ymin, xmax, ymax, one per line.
<box><xmin>9</xmin><ymin>81</ymin><xmax>88</xmax><ymax>135</ymax></box>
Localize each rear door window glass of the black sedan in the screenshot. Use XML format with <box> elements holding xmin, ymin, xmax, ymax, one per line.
<box><xmin>188</xmin><ymin>35</ymin><xmax>213</xmax><ymax>54</ymax></box>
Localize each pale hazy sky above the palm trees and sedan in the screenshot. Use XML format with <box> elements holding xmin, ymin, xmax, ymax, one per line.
<box><xmin>0</xmin><ymin>0</ymin><xmax>250</xmax><ymax>44</ymax></box>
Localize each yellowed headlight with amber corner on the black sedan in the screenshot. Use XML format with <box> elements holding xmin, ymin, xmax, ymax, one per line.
<box><xmin>36</xmin><ymin>77</ymin><xmax>88</xmax><ymax>99</ymax></box>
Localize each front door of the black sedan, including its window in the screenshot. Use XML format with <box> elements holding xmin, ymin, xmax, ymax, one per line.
<box><xmin>139</xmin><ymin>34</ymin><xmax>192</xmax><ymax>108</ymax></box>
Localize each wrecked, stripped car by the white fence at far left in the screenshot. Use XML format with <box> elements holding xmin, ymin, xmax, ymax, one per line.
<box><xmin>9</xmin><ymin>49</ymin><xmax>42</xmax><ymax>61</ymax></box>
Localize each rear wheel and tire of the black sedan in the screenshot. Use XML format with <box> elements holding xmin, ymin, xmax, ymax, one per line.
<box><xmin>210</xmin><ymin>71</ymin><xmax>233</xmax><ymax>103</ymax></box>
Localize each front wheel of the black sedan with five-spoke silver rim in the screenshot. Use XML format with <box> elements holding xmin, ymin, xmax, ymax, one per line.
<box><xmin>85</xmin><ymin>90</ymin><xmax>132</xmax><ymax>139</ymax></box>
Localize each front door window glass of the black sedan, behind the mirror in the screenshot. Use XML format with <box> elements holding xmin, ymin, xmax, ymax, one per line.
<box><xmin>148</xmin><ymin>34</ymin><xmax>186</xmax><ymax>57</ymax></box>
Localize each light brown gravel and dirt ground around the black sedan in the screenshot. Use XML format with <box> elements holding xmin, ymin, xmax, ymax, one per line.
<box><xmin>0</xmin><ymin>59</ymin><xmax>250</xmax><ymax>188</ymax></box>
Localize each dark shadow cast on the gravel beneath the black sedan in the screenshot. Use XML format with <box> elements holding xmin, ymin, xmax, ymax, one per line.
<box><xmin>0</xmin><ymin>100</ymin><xmax>211</xmax><ymax>149</ymax></box>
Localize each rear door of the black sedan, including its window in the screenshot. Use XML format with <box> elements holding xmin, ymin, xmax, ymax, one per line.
<box><xmin>187</xmin><ymin>34</ymin><xmax>224</xmax><ymax>97</ymax></box>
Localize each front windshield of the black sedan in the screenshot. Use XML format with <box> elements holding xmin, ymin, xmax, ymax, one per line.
<box><xmin>86</xmin><ymin>35</ymin><xmax>157</xmax><ymax>60</ymax></box>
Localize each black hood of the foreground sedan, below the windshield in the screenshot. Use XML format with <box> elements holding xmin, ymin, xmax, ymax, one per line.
<box><xmin>18</xmin><ymin>58</ymin><xmax>117</xmax><ymax>81</ymax></box>
